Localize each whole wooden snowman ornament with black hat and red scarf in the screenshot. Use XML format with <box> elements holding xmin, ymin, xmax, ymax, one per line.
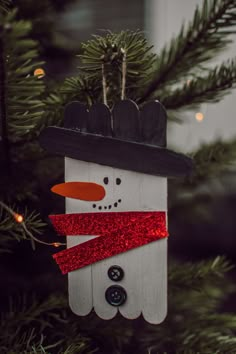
<box><xmin>40</xmin><ymin>100</ymin><xmax>192</xmax><ymax>324</ymax></box>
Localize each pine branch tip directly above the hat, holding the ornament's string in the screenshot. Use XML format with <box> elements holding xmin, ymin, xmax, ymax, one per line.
<box><xmin>41</xmin><ymin>31</ymin><xmax>155</xmax><ymax>119</ymax></box>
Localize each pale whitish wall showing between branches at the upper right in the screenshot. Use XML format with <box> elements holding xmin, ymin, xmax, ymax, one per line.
<box><xmin>145</xmin><ymin>0</ymin><xmax>236</xmax><ymax>151</ymax></box>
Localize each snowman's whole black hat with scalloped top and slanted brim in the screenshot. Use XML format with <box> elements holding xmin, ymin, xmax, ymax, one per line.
<box><xmin>40</xmin><ymin>100</ymin><xmax>192</xmax><ymax>177</ymax></box>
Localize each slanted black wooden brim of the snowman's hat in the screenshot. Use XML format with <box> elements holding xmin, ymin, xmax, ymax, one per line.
<box><xmin>39</xmin><ymin>127</ymin><xmax>193</xmax><ymax>177</ymax></box>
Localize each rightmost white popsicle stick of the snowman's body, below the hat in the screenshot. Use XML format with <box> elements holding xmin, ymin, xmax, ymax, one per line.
<box><xmin>140</xmin><ymin>175</ymin><xmax>167</xmax><ymax>324</ymax></box>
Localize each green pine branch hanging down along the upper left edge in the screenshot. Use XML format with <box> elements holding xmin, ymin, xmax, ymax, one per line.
<box><xmin>1</xmin><ymin>11</ymin><xmax>44</xmax><ymax>142</ymax></box>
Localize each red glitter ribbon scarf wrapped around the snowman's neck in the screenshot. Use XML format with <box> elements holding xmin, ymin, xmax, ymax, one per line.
<box><xmin>50</xmin><ymin>211</ymin><xmax>168</xmax><ymax>274</ymax></box>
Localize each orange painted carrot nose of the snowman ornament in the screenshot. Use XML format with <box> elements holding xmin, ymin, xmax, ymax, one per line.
<box><xmin>51</xmin><ymin>182</ymin><xmax>106</xmax><ymax>201</ymax></box>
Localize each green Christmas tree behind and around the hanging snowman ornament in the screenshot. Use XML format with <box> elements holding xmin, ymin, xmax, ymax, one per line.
<box><xmin>0</xmin><ymin>0</ymin><xmax>236</xmax><ymax>354</ymax></box>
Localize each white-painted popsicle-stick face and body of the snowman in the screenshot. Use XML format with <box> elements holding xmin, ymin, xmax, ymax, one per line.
<box><xmin>66</xmin><ymin>159</ymin><xmax>167</xmax><ymax>323</ymax></box>
